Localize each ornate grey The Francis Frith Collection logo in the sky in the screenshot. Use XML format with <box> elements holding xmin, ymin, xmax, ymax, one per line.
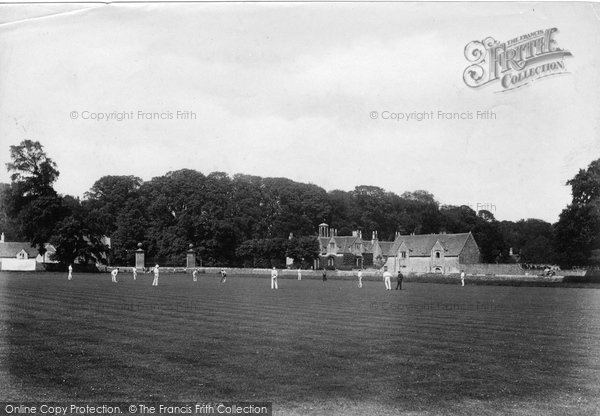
<box><xmin>463</xmin><ymin>27</ymin><xmax>572</xmax><ymax>91</ymax></box>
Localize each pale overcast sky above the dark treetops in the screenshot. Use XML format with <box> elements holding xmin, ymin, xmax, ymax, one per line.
<box><xmin>0</xmin><ymin>3</ymin><xmax>600</xmax><ymax>222</ymax></box>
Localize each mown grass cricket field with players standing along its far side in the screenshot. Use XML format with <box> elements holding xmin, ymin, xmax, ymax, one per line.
<box><xmin>0</xmin><ymin>272</ymin><xmax>600</xmax><ymax>415</ymax></box>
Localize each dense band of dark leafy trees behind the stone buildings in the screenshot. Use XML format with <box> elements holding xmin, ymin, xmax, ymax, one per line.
<box><xmin>0</xmin><ymin>140</ymin><xmax>600</xmax><ymax>267</ymax></box>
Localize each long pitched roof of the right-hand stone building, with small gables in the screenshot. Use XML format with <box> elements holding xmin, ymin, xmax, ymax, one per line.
<box><xmin>392</xmin><ymin>233</ymin><xmax>471</xmax><ymax>257</ymax></box>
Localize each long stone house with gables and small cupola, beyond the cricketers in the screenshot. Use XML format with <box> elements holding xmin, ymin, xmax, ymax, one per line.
<box><xmin>315</xmin><ymin>223</ymin><xmax>480</xmax><ymax>274</ymax></box>
